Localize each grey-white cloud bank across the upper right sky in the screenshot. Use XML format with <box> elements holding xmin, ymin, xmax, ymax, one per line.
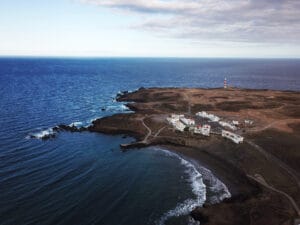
<box><xmin>82</xmin><ymin>0</ymin><xmax>300</xmax><ymax>44</ymax></box>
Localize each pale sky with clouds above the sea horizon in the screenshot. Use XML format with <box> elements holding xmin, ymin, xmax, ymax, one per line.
<box><xmin>0</xmin><ymin>0</ymin><xmax>300</xmax><ymax>58</ymax></box>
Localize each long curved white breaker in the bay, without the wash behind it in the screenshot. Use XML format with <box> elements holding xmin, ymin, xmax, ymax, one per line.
<box><xmin>156</xmin><ymin>148</ymin><xmax>206</xmax><ymax>225</ymax></box>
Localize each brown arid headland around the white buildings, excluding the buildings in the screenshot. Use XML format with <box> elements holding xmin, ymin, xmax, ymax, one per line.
<box><xmin>59</xmin><ymin>88</ymin><xmax>300</xmax><ymax>225</ymax></box>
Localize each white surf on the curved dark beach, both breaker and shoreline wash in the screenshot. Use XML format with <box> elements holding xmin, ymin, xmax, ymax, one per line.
<box><xmin>155</xmin><ymin>148</ymin><xmax>231</xmax><ymax>225</ymax></box>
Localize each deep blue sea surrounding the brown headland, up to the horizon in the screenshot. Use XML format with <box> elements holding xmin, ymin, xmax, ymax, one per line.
<box><xmin>0</xmin><ymin>58</ymin><xmax>300</xmax><ymax>225</ymax></box>
